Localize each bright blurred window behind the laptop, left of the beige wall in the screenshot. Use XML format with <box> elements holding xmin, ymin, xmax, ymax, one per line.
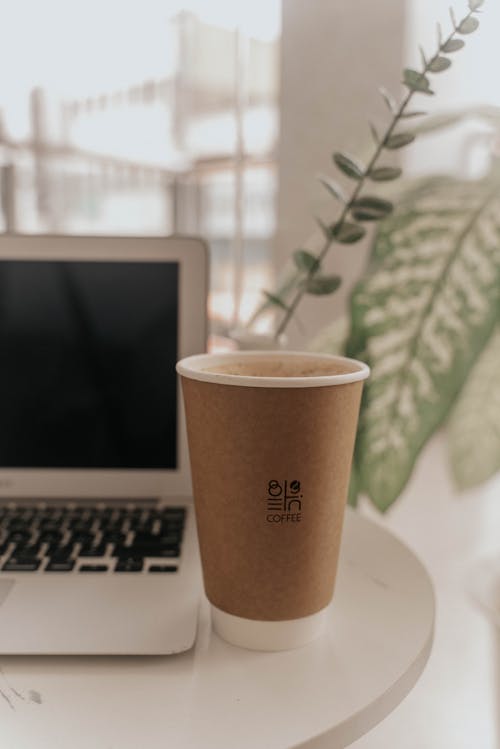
<box><xmin>0</xmin><ymin>0</ymin><xmax>280</xmax><ymax>342</ymax></box>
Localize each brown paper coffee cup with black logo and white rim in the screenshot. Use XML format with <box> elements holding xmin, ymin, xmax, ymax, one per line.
<box><xmin>177</xmin><ymin>351</ymin><xmax>369</xmax><ymax>650</ymax></box>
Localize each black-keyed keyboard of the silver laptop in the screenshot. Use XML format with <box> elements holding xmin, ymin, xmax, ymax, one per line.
<box><xmin>0</xmin><ymin>504</ymin><xmax>187</xmax><ymax>574</ymax></box>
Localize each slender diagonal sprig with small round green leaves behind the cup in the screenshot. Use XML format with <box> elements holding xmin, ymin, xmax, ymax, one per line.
<box><xmin>250</xmin><ymin>0</ymin><xmax>484</xmax><ymax>339</ymax></box>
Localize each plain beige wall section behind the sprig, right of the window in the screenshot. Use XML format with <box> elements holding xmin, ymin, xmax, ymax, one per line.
<box><xmin>276</xmin><ymin>0</ymin><xmax>405</xmax><ymax>345</ymax></box>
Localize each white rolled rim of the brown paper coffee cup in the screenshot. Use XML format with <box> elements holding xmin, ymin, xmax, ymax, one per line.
<box><xmin>176</xmin><ymin>350</ymin><xmax>370</xmax><ymax>388</ymax></box>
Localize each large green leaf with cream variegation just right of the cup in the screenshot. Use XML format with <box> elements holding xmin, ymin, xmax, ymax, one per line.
<box><xmin>346</xmin><ymin>180</ymin><xmax>500</xmax><ymax>510</ymax></box>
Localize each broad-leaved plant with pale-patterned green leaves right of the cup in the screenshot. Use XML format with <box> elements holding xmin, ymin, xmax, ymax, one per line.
<box><xmin>304</xmin><ymin>95</ymin><xmax>500</xmax><ymax>510</ymax></box>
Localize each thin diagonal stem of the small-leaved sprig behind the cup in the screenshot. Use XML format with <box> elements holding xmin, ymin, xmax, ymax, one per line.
<box><xmin>274</xmin><ymin>0</ymin><xmax>482</xmax><ymax>340</ymax></box>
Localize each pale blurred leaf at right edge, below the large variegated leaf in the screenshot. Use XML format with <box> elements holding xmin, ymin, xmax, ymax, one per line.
<box><xmin>448</xmin><ymin>328</ymin><xmax>500</xmax><ymax>489</ymax></box>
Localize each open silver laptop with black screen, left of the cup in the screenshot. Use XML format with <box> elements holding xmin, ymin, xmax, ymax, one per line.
<box><xmin>0</xmin><ymin>235</ymin><xmax>207</xmax><ymax>655</ymax></box>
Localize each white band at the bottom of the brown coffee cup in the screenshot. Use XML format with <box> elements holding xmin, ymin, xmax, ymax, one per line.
<box><xmin>211</xmin><ymin>605</ymin><xmax>329</xmax><ymax>650</ymax></box>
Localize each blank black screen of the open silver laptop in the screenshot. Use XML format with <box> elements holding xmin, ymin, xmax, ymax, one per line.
<box><xmin>0</xmin><ymin>260</ymin><xmax>179</xmax><ymax>470</ymax></box>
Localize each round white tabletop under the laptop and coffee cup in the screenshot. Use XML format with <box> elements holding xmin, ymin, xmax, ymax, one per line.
<box><xmin>0</xmin><ymin>511</ymin><xmax>434</xmax><ymax>749</ymax></box>
